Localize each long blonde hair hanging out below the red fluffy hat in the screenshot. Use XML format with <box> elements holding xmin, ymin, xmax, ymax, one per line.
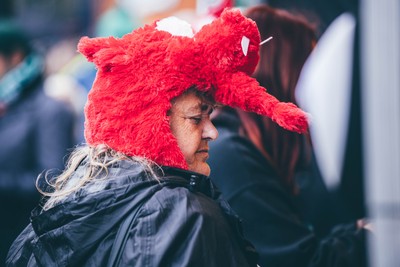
<box><xmin>36</xmin><ymin>145</ymin><xmax>161</xmax><ymax>210</ymax></box>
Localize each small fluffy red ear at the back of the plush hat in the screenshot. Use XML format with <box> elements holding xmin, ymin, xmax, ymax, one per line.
<box><xmin>78</xmin><ymin>36</ymin><xmax>128</xmax><ymax>71</ymax></box>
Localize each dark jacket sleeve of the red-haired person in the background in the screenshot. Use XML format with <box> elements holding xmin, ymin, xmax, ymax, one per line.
<box><xmin>210</xmin><ymin>131</ymin><xmax>364</xmax><ymax>267</ymax></box>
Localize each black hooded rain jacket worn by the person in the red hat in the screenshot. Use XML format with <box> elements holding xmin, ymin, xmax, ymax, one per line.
<box><xmin>7</xmin><ymin>161</ymin><xmax>256</xmax><ymax>267</ymax></box>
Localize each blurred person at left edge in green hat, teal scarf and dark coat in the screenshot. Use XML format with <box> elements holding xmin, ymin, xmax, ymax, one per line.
<box><xmin>0</xmin><ymin>20</ymin><xmax>74</xmax><ymax>263</ymax></box>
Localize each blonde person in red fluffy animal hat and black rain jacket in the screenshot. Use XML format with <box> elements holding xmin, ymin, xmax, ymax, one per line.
<box><xmin>7</xmin><ymin>9</ymin><xmax>307</xmax><ymax>266</ymax></box>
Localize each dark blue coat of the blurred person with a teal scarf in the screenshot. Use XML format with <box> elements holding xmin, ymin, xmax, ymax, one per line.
<box><xmin>0</xmin><ymin>79</ymin><xmax>74</xmax><ymax>266</ymax></box>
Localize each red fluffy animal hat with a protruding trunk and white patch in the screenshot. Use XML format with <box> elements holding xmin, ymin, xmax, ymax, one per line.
<box><xmin>78</xmin><ymin>9</ymin><xmax>307</xmax><ymax>169</ymax></box>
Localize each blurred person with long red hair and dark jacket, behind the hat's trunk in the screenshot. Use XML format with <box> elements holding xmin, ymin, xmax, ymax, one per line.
<box><xmin>209</xmin><ymin>5</ymin><xmax>365</xmax><ymax>266</ymax></box>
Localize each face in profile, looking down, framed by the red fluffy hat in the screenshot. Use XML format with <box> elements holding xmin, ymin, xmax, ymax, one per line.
<box><xmin>169</xmin><ymin>93</ymin><xmax>218</xmax><ymax>176</ymax></box>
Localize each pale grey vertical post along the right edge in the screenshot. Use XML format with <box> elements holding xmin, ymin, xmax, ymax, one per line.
<box><xmin>360</xmin><ymin>0</ymin><xmax>400</xmax><ymax>267</ymax></box>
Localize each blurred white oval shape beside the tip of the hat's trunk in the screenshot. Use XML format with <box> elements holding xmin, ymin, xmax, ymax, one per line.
<box><xmin>296</xmin><ymin>13</ymin><xmax>356</xmax><ymax>189</ymax></box>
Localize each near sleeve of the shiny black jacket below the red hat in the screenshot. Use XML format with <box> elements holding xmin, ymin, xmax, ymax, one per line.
<box><xmin>123</xmin><ymin>188</ymin><xmax>255</xmax><ymax>267</ymax></box>
